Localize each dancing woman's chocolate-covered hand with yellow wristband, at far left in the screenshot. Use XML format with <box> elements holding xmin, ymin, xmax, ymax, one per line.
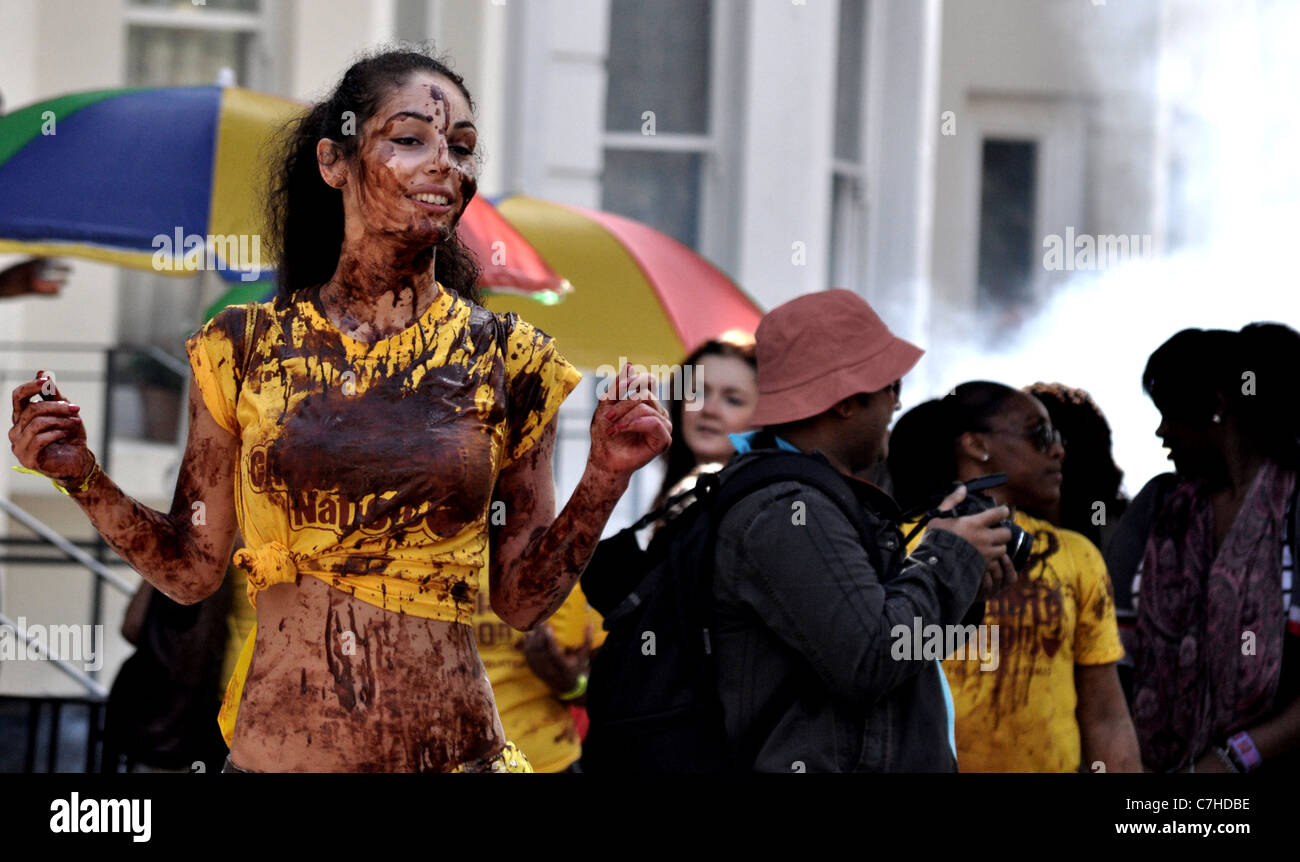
<box><xmin>9</xmin><ymin>371</ymin><xmax>95</xmax><ymax>484</ymax></box>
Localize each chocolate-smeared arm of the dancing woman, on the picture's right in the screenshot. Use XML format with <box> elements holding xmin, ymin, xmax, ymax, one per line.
<box><xmin>489</xmin><ymin>367</ymin><xmax>672</xmax><ymax>632</ymax></box>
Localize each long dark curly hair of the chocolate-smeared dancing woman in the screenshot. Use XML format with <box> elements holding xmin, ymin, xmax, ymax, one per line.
<box><xmin>267</xmin><ymin>48</ymin><xmax>482</xmax><ymax>304</ymax></box>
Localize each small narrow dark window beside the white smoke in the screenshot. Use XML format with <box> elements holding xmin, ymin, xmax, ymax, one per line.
<box><xmin>979</xmin><ymin>139</ymin><xmax>1037</xmax><ymax>306</ymax></box>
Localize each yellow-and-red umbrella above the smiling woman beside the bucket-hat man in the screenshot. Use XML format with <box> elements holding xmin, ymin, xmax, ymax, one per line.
<box><xmin>488</xmin><ymin>195</ymin><xmax>763</xmax><ymax>368</ymax></box>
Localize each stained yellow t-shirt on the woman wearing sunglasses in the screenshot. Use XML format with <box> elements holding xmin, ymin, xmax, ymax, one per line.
<box><xmin>917</xmin><ymin>512</ymin><xmax>1125</xmax><ymax>772</ymax></box>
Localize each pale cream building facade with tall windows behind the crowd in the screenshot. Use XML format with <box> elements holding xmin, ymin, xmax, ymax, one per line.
<box><xmin>0</xmin><ymin>0</ymin><xmax>1190</xmax><ymax>693</ymax></box>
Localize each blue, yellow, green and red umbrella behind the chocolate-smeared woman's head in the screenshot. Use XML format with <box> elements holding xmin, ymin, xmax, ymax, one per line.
<box><xmin>0</xmin><ymin>87</ymin><xmax>568</xmax><ymax>302</ymax></box>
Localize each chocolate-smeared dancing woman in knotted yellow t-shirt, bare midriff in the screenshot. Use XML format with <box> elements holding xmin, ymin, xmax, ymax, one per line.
<box><xmin>9</xmin><ymin>52</ymin><xmax>670</xmax><ymax>771</ymax></box>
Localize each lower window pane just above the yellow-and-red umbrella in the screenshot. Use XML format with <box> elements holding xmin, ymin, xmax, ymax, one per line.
<box><xmin>601</xmin><ymin>150</ymin><xmax>703</xmax><ymax>248</ymax></box>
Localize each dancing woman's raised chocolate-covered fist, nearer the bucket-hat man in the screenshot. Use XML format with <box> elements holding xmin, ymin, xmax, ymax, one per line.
<box><xmin>588</xmin><ymin>364</ymin><xmax>672</xmax><ymax>477</ymax></box>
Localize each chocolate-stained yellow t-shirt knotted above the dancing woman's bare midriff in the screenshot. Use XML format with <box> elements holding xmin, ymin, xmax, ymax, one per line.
<box><xmin>186</xmin><ymin>289</ymin><xmax>581</xmax><ymax>741</ymax></box>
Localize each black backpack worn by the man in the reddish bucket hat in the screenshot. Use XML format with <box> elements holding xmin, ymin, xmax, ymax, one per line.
<box><xmin>582</xmin><ymin>451</ymin><xmax>883</xmax><ymax>774</ymax></box>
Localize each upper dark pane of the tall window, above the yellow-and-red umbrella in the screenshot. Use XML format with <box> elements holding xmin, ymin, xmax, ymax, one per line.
<box><xmin>605</xmin><ymin>0</ymin><xmax>711</xmax><ymax>134</ymax></box>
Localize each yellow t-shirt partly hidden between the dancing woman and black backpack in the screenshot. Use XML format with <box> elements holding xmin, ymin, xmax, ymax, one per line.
<box><xmin>473</xmin><ymin>568</ymin><xmax>607</xmax><ymax>772</ymax></box>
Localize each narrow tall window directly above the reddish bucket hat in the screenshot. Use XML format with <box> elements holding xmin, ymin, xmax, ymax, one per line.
<box><xmin>827</xmin><ymin>0</ymin><xmax>867</xmax><ymax>290</ymax></box>
